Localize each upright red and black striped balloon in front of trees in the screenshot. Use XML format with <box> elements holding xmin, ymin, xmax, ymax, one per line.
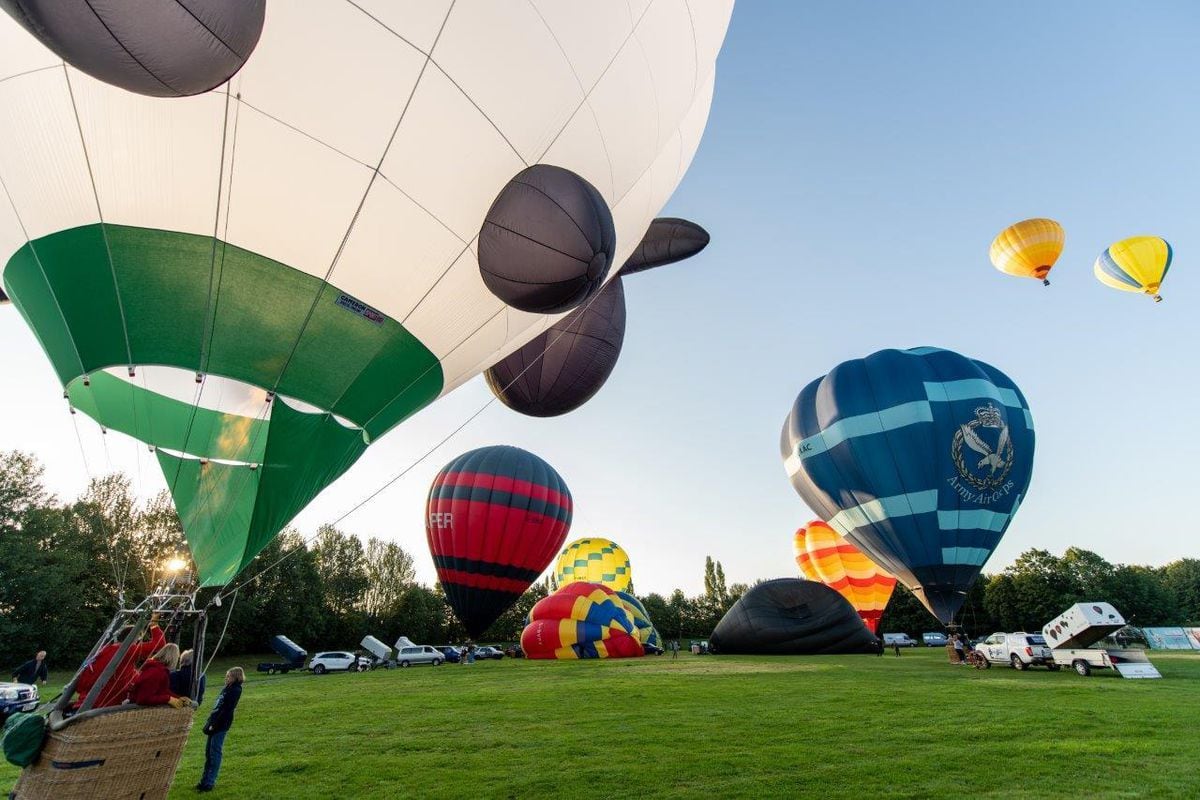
<box><xmin>425</xmin><ymin>445</ymin><xmax>572</xmax><ymax>637</ymax></box>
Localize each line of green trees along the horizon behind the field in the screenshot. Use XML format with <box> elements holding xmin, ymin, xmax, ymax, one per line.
<box><xmin>0</xmin><ymin>451</ymin><xmax>1200</xmax><ymax>679</ymax></box>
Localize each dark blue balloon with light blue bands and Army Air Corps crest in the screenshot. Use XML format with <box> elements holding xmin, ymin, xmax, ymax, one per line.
<box><xmin>780</xmin><ymin>347</ymin><xmax>1034</xmax><ymax>622</ymax></box>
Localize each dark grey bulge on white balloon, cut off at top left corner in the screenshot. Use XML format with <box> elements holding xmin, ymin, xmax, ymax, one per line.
<box><xmin>0</xmin><ymin>0</ymin><xmax>265</xmax><ymax>97</ymax></box>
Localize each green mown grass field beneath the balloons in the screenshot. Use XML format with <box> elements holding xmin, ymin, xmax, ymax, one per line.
<box><xmin>9</xmin><ymin>649</ymin><xmax>1200</xmax><ymax>799</ymax></box>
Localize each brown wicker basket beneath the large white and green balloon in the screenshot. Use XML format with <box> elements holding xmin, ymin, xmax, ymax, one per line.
<box><xmin>14</xmin><ymin>705</ymin><xmax>192</xmax><ymax>800</ymax></box>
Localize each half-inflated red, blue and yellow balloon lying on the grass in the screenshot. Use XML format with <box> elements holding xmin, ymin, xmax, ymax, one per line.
<box><xmin>521</xmin><ymin>582</ymin><xmax>646</xmax><ymax>660</ymax></box>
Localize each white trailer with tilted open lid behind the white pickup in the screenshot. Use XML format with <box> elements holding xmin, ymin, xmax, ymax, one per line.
<box><xmin>1042</xmin><ymin>602</ymin><xmax>1162</xmax><ymax>678</ymax></box>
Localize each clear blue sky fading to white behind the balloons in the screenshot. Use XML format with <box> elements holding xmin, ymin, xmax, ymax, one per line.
<box><xmin>0</xmin><ymin>0</ymin><xmax>1200</xmax><ymax>591</ymax></box>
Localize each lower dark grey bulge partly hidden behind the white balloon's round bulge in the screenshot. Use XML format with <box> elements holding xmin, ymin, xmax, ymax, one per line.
<box><xmin>484</xmin><ymin>278</ymin><xmax>625</xmax><ymax>416</ymax></box>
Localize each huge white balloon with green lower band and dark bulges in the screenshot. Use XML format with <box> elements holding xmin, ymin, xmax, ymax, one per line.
<box><xmin>0</xmin><ymin>0</ymin><xmax>732</xmax><ymax>587</ymax></box>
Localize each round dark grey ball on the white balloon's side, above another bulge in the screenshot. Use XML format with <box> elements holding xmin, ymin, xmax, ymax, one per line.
<box><xmin>479</xmin><ymin>164</ymin><xmax>617</xmax><ymax>314</ymax></box>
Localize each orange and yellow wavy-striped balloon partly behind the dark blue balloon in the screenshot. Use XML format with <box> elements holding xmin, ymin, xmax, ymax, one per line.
<box><xmin>792</xmin><ymin>519</ymin><xmax>896</xmax><ymax>633</ymax></box>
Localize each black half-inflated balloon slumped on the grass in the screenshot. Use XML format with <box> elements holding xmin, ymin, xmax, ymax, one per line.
<box><xmin>709</xmin><ymin>578</ymin><xmax>878</xmax><ymax>656</ymax></box>
